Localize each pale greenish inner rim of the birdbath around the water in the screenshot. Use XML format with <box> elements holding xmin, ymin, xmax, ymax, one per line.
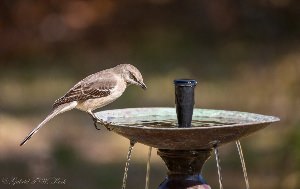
<box><xmin>95</xmin><ymin>107</ymin><xmax>280</xmax><ymax>130</ymax></box>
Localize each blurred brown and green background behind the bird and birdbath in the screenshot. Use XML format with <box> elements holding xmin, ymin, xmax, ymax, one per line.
<box><xmin>0</xmin><ymin>0</ymin><xmax>300</xmax><ymax>189</ymax></box>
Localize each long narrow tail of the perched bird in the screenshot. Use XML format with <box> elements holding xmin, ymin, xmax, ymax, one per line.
<box><xmin>20</xmin><ymin>101</ymin><xmax>77</xmax><ymax>146</ymax></box>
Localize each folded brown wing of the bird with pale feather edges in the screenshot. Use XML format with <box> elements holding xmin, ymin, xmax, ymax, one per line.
<box><xmin>53</xmin><ymin>73</ymin><xmax>117</xmax><ymax>108</ymax></box>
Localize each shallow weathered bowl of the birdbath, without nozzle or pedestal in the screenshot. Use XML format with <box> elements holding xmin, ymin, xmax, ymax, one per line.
<box><xmin>96</xmin><ymin>108</ymin><xmax>279</xmax><ymax>150</ymax></box>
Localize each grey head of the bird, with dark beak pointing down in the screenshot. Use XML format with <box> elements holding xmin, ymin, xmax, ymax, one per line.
<box><xmin>116</xmin><ymin>64</ymin><xmax>147</xmax><ymax>89</ymax></box>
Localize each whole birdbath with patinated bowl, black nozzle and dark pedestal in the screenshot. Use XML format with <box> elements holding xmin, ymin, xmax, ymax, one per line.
<box><xmin>96</xmin><ymin>80</ymin><xmax>279</xmax><ymax>189</ymax></box>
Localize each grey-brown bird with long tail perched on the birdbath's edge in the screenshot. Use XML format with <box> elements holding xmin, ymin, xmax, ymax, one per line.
<box><xmin>20</xmin><ymin>64</ymin><xmax>147</xmax><ymax>146</ymax></box>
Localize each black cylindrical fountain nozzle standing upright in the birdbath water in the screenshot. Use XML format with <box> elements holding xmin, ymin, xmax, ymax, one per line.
<box><xmin>174</xmin><ymin>79</ymin><xmax>197</xmax><ymax>127</ymax></box>
